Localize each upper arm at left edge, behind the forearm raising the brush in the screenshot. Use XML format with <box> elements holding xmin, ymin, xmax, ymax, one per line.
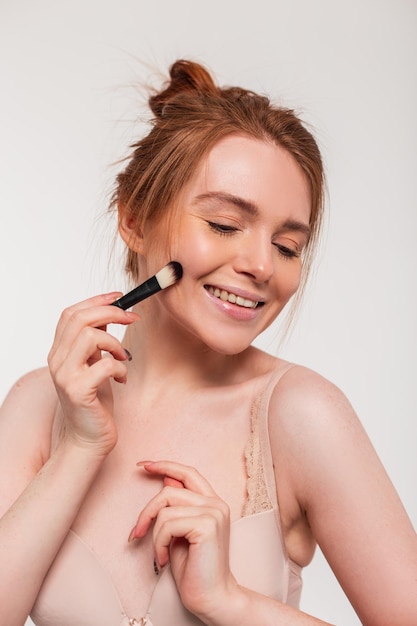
<box><xmin>0</xmin><ymin>368</ymin><xmax>57</xmax><ymax>517</ymax></box>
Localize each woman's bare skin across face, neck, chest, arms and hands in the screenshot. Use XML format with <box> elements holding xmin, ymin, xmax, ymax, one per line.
<box><xmin>0</xmin><ymin>136</ymin><xmax>417</xmax><ymax>626</ymax></box>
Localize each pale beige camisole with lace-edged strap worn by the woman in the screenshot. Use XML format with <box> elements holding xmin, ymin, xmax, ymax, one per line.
<box><xmin>31</xmin><ymin>361</ymin><xmax>302</xmax><ymax>626</ymax></box>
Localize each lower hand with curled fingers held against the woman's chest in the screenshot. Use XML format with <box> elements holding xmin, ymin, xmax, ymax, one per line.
<box><xmin>130</xmin><ymin>461</ymin><xmax>236</xmax><ymax>616</ymax></box>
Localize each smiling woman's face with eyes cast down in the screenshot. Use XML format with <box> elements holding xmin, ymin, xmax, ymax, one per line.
<box><xmin>138</xmin><ymin>136</ymin><xmax>310</xmax><ymax>354</ymax></box>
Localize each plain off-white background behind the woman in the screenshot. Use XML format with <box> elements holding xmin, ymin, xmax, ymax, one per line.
<box><xmin>0</xmin><ymin>0</ymin><xmax>417</xmax><ymax>626</ymax></box>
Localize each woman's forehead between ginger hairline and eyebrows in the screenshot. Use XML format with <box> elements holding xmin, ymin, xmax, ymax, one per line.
<box><xmin>186</xmin><ymin>135</ymin><xmax>311</xmax><ymax>224</ymax></box>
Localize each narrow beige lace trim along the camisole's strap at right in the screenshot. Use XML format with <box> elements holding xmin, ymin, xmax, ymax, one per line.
<box><xmin>242</xmin><ymin>396</ymin><xmax>273</xmax><ymax>516</ymax></box>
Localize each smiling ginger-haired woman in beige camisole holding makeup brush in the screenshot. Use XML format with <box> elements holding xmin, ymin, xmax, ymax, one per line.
<box><xmin>0</xmin><ymin>61</ymin><xmax>417</xmax><ymax>626</ymax></box>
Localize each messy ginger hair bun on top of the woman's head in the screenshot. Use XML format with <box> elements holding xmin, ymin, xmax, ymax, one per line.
<box><xmin>149</xmin><ymin>59</ymin><xmax>218</xmax><ymax>117</ymax></box>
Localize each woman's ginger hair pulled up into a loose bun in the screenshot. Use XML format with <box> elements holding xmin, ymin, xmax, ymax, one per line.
<box><xmin>111</xmin><ymin>59</ymin><xmax>324</xmax><ymax>312</ymax></box>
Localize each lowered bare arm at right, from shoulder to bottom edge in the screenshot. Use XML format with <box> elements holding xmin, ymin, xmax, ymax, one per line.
<box><xmin>270</xmin><ymin>368</ymin><xmax>417</xmax><ymax>626</ymax></box>
